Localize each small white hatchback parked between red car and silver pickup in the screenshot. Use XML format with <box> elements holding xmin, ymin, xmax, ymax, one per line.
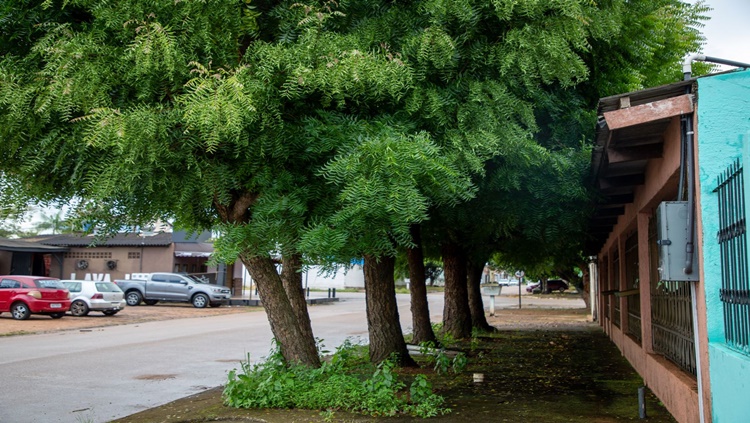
<box><xmin>62</xmin><ymin>280</ymin><xmax>125</xmax><ymax>317</ymax></box>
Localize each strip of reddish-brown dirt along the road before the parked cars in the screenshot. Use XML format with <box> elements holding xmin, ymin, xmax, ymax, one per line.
<box><xmin>0</xmin><ymin>303</ymin><xmax>261</xmax><ymax>336</ymax></box>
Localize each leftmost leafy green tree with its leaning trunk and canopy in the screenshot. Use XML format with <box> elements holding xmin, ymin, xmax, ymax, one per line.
<box><xmin>0</xmin><ymin>0</ymin><xmax>418</xmax><ymax>366</ymax></box>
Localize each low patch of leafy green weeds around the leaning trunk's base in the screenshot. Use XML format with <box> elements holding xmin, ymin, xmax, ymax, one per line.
<box><xmin>224</xmin><ymin>341</ymin><xmax>450</xmax><ymax>417</ymax></box>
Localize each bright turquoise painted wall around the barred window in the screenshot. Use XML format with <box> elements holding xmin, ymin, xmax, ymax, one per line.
<box><xmin>697</xmin><ymin>71</ymin><xmax>750</xmax><ymax>423</ymax></box>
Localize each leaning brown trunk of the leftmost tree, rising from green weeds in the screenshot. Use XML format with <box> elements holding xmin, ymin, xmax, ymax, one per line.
<box><xmin>241</xmin><ymin>256</ymin><xmax>320</xmax><ymax>367</ymax></box>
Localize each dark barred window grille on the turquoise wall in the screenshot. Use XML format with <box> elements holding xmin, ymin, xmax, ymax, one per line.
<box><xmin>714</xmin><ymin>159</ymin><xmax>750</xmax><ymax>355</ymax></box>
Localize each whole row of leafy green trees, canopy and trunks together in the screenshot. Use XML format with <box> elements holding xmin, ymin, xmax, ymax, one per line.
<box><xmin>0</xmin><ymin>0</ymin><xmax>707</xmax><ymax>366</ymax></box>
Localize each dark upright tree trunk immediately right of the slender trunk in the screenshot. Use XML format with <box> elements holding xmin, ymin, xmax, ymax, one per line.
<box><xmin>442</xmin><ymin>241</ymin><xmax>471</xmax><ymax>339</ymax></box>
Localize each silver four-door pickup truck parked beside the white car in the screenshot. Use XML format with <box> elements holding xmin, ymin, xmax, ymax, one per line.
<box><xmin>114</xmin><ymin>273</ymin><xmax>231</xmax><ymax>308</ymax></box>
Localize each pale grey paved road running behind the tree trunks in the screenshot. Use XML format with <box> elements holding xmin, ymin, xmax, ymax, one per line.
<box><xmin>0</xmin><ymin>293</ymin><xmax>582</xmax><ymax>423</ymax></box>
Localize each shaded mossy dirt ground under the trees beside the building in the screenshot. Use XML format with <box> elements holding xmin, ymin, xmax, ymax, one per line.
<box><xmin>108</xmin><ymin>308</ymin><xmax>675</xmax><ymax>423</ymax></box>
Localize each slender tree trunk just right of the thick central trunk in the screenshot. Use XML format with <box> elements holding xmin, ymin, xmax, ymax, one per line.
<box><xmin>406</xmin><ymin>225</ymin><xmax>437</xmax><ymax>345</ymax></box>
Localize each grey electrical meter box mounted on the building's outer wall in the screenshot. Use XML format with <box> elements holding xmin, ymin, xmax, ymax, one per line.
<box><xmin>656</xmin><ymin>201</ymin><xmax>698</xmax><ymax>282</ymax></box>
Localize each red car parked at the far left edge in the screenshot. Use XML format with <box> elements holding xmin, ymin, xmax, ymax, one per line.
<box><xmin>0</xmin><ymin>275</ymin><xmax>70</xmax><ymax>320</ymax></box>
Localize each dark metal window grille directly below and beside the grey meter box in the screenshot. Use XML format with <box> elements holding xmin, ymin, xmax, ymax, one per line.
<box><xmin>648</xmin><ymin>217</ymin><xmax>696</xmax><ymax>376</ymax></box>
